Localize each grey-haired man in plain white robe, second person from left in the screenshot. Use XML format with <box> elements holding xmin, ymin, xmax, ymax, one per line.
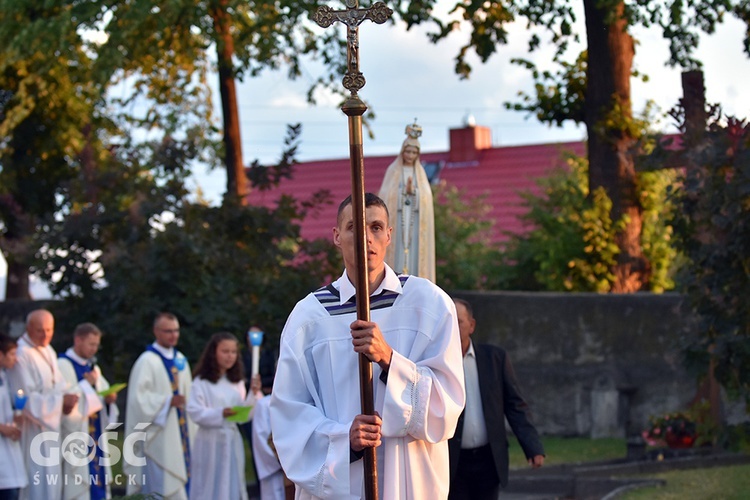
<box><xmin>9</xmin><ymin>309</ymin><xmax>78</xmax><ymax>500</ymax></box>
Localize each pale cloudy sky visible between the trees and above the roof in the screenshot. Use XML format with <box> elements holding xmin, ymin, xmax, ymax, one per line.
<box><xmin>0</xmin><ymin>0</ymin><xmax>750</xmax><ymax>298</ymax></box>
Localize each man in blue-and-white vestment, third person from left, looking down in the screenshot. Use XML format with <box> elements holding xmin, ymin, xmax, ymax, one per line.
<box><xmin>57</xmin><ymin>323</ymin><xmax>120</xmax><ymax>500</ymax></box>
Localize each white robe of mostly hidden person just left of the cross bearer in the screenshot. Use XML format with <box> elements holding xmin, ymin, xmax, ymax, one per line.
<box><xmin>253</xmin><ymin>396</ymin><xmax>286</xmax><ymax>500</ymax></box>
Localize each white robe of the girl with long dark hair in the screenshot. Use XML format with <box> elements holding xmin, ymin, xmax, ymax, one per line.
<box><xmin>187</xmin><ymin>376</ymin><xmax>255</xmax><ymax>500</ymax></box>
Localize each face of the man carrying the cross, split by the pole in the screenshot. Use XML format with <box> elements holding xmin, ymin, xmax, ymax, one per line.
<box><xmin>333</xmin><ymin>205</ymin><xmax>391</xmax><ymax>272</ymax></box>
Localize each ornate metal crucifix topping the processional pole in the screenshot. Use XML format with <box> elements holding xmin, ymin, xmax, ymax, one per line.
<box><xmin>312</xmin><ymin>0</ymin><xmax>393</xmax><ymax>96</ymax></box>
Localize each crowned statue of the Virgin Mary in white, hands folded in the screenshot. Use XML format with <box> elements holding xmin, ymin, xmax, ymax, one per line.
<box><xmin>379</xmin><ymin>120</ymin><xmax>435</xmax><ymax>283</ymax></box>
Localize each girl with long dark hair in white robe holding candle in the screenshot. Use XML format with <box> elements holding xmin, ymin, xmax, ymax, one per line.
<box><xmin>187</xmin><ymin>332</ymin><xmax>263</xmax><ymax>500</ymax></box>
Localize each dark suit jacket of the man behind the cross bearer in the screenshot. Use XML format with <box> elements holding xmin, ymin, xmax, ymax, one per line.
<box><xmin>448</xmin><ymin>344</ymin><xmax>544</xmax><ymax>487</ymax></box>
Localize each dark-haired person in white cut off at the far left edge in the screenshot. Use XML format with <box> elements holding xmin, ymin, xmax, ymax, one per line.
<box><xmin>0</xmin><ymin>333</ymin><xmax>29</xmax><ymax>500</ymax></box>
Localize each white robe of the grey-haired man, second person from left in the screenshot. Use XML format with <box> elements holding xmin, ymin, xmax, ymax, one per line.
<box><xmin>10</xmin><ymin>333</ymin><xmax>68</xmax><ymax>500</ymax></box>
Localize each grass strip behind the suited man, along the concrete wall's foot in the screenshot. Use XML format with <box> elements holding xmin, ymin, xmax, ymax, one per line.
<box><xmin>509</xmin><ymin>436</ymin><xmax>627</xmax><ymax>469</ymax></box>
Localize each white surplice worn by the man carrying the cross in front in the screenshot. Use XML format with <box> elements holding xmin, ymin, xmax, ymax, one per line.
<box><xmin>271</xmin><ymin>266</ymin><xmax>465</xmax><ymax>500</ymax></box>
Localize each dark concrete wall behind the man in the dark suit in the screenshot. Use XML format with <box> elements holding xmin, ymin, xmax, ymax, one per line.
<box><xmin>455</xmin><ymin>292</ymin><xmax>697</xmax><ymax>437</ymax></box>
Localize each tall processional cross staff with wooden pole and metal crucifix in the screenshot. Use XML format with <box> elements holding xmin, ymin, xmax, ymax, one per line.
<box><xmin>312</xmin><ymin>0</ymin><xmax>393</xmax><ymax>500</ymax></box>
